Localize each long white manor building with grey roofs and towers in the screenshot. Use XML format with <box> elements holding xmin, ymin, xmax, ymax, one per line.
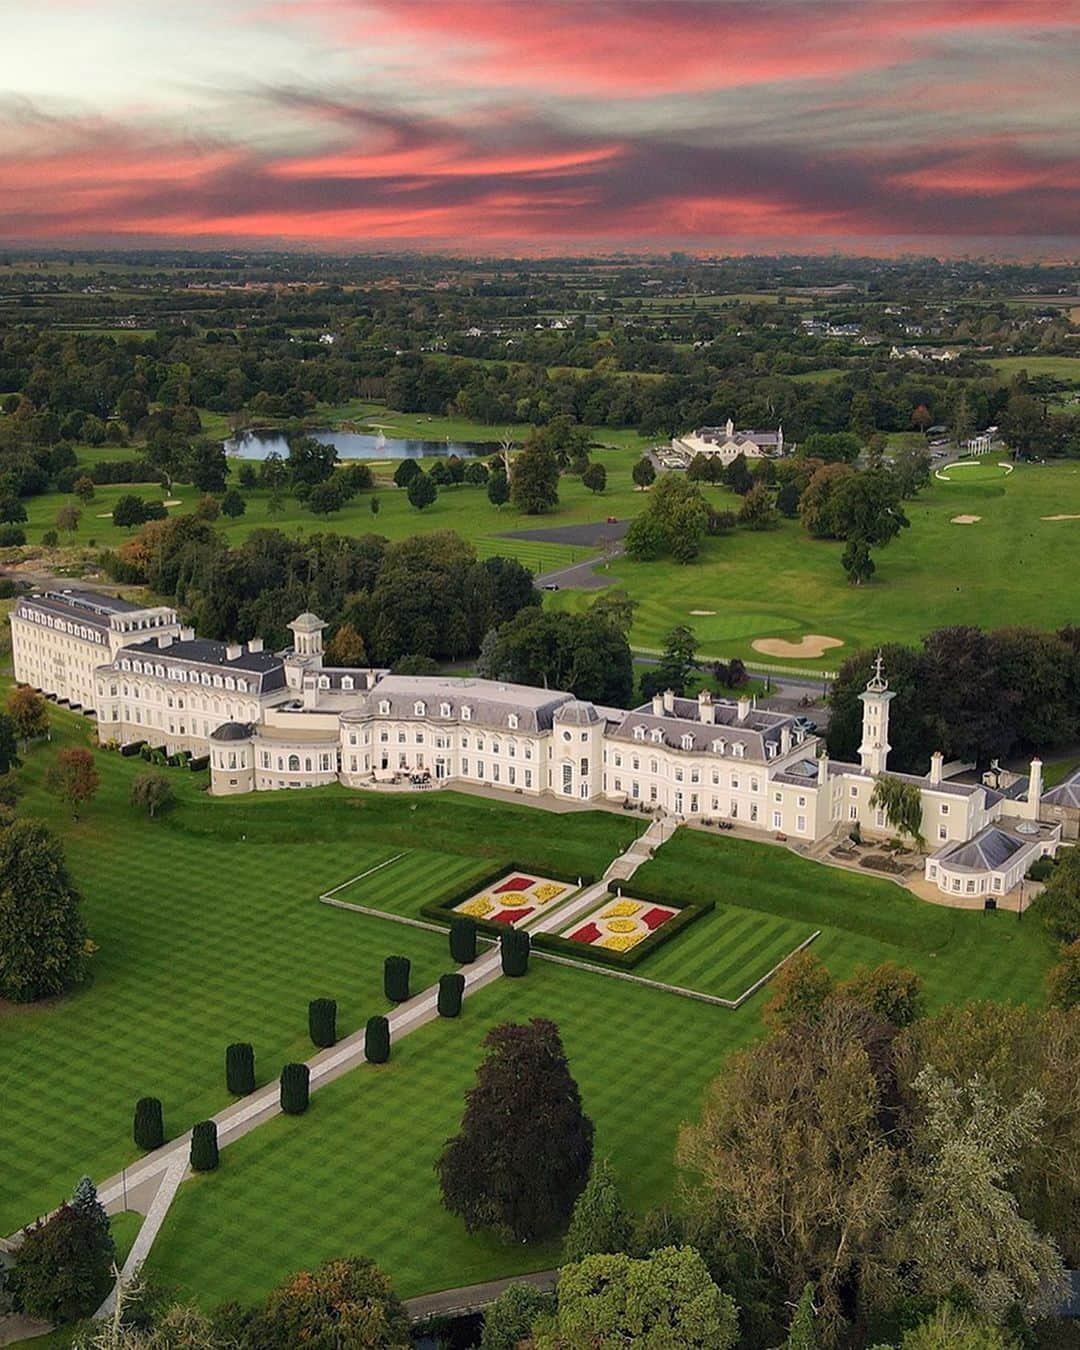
<box><xmin>11</xmin><ymin>590</ymin><xmax>1080</xmax><ymax>898</ymax></box>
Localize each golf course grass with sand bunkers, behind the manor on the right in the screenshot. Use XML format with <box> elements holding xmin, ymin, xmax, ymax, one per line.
<box><xmin>545</xmin><ymin>462</ymin><xmax>1080</xmax><ymax>670</ymax></box>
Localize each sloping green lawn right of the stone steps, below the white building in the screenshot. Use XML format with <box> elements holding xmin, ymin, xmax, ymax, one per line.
<box><xmin>635</xmin><ymin>829</ymin><xmax>1054</xmax><ymax>1006</ymax></box>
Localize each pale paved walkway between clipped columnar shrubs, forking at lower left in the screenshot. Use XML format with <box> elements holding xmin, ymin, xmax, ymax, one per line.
<box><xmin>12</xmin><ymin>819</ymin><xmax>675</xmax><ymax>1316</ymax></box>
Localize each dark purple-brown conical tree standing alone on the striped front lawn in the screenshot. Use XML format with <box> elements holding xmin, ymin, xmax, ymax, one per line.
<box><xmin>436</xmin><ymin>1018</ymin><xmax>593</xmax><ymax>1242</ymax></box>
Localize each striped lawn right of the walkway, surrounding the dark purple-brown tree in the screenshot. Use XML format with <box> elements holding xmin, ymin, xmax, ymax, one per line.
<box><xmin>149</xmin><ymin>961</ymin><xmax>757</xmax><ymax>1307</ymax></box>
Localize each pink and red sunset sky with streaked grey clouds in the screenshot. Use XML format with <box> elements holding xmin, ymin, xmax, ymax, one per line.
<box><xmin>0</xmin><ymin>0</ymin><xmax>1080</xmax><ymax>259</ymax></box>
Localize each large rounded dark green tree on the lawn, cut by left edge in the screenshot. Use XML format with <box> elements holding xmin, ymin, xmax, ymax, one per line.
<box><xmin>0</xmin><ymin>821</ymin><xmax>86</xmax><ymax>1003</ymax></box>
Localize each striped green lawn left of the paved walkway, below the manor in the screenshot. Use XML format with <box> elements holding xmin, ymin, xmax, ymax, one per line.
<box><xmin>0</xmin><ymin>710</ymin><xmax>640</xmax><ymax>1233</ymax></box>
